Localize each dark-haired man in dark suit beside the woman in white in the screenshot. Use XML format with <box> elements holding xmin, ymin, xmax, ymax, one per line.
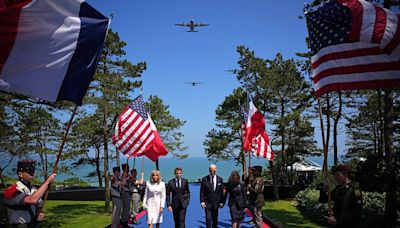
<box><xmin>167</xmin><ymin>167</ymin><xmax>190</xmax><ymax>228</ymax></box>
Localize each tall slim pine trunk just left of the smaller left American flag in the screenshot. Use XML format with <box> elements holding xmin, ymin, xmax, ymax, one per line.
<box><xmin>103</xmin><ymin>104</ymin><xmax>111</xmax><ymax>213</ymax></box>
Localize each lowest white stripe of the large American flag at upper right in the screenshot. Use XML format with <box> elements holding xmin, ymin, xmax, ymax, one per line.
<box><xmin>314</xmin><ymin>70</ymin><xmax>400</xmax><ymax>90</ymax></box>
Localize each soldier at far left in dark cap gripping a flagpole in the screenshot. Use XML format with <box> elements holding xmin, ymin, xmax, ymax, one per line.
<box><xmin>4</xmin><ymin>160</ymin><xmax>56</xmax><ymax>228</ymax></box>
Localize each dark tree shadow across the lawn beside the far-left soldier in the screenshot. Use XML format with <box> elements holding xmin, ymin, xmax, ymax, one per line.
<box><xmin>42</xmin><ymin>204</ymin><xmax>104</xmax><ymax>227</ymax></box>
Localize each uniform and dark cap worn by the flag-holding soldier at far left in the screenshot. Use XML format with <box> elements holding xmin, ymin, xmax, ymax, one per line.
<box><xmin>4</xmin><ymin>161</ymin><xmax>42</xmax><ymax>228</ymax></box>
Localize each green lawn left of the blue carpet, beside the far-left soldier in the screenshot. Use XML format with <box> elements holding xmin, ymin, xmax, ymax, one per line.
<box><xmin>42</xmin><ymin>200</ymin><xmax>111</xmax><ymax>228</ymax></box>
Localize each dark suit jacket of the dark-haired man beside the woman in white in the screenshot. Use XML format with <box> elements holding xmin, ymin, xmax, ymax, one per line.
<box><xmin>167</xmin><ymin>178</ymin><xmax>190</xmax><ymax>208</ymax></box>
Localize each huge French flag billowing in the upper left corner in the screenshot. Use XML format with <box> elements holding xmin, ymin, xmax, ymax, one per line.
<box><xmin>0</xmin><ymin>0</ymin><xmax>109</xmax><ymax>105</ymax></box>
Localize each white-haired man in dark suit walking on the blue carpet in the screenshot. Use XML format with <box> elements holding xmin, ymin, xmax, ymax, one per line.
<box><xmin>200</xmin><ymin>164</ymin><xmax>225</xmax><ymax>228</ymax></box>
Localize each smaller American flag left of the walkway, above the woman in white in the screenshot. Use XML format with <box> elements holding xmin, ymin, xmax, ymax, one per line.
<box><xmin>112</xmin><ymin>95</ymin><xmax>154</xmax><ymax>156</ymax></box>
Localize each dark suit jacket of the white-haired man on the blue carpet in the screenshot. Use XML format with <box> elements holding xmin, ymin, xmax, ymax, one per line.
<box><xmin>200</xmin><ymin>175</ymin><xmax>225</xmax><ymax>209</ymax></box>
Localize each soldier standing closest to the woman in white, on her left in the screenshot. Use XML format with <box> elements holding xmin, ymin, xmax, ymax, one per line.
<box><xmin>128</xmin><ymin>169</ymin><xmax>144</xmax><ymax>225</ymax></box>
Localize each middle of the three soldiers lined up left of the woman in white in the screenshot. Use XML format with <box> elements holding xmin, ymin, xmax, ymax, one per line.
<box><xmin>121</xmin><ymin>164</ymin><xmax>132</xmax><ymax>227</ymax></box>
